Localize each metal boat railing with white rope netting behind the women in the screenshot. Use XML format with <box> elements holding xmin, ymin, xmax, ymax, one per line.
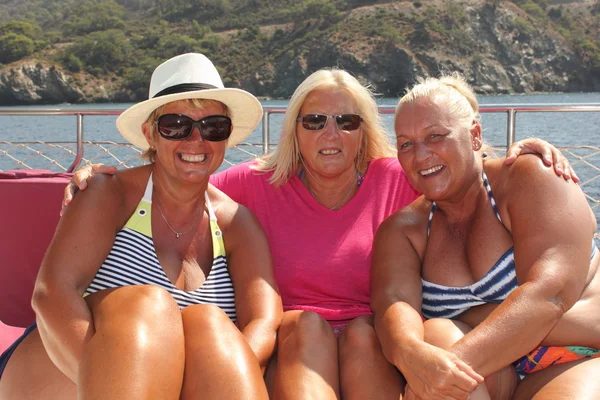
<box><xmin>0</xmin><ymin>104</ymin><xmax>600</xmax><ymax>240</ymax></box>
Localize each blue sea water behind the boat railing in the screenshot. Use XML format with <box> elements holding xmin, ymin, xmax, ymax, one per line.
<box><xmin>0</xmin><ymin>93</ymin><xmax>600</xmax><ymax>234</ymax></box>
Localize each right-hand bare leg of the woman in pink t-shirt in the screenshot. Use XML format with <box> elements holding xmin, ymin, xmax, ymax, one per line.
<box><xmin>338</xmin><ymin>316</ymin><xmax>404</xmax><ymax>400</ymax></box>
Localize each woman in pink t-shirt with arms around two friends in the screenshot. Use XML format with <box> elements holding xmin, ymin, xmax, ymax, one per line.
<box><xmin>66</xmin><ymin>69</ymin><xmax>570</xmax><ymax>399</ymax></box>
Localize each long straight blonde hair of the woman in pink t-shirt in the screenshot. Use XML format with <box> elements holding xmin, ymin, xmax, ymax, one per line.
<box><xmin>253</xmin><ymin>68</ymin><xmax>396</xmax><ymax>186</ymax></box>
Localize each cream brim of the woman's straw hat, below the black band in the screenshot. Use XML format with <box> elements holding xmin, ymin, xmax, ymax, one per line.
<box><xmin>117</xmin><ymin>88</ymin><xmax>263</xmax><ymax>150</ymax></box>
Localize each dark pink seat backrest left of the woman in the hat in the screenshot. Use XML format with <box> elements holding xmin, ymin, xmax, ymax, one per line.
<box><xmin>0</xmin><ymin>170</ymin><xmax>71</xmax><ymax>327</ymax></box>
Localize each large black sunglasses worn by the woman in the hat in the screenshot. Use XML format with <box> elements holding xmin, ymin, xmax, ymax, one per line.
<box><xmin>156</xmin><ymin>114</ymin><xmax>231</xmax><ymax>142</ymax></box>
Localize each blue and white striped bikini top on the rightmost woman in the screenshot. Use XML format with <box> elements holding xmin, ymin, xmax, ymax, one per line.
<box><xmin>421</xmin><ymin>171</ymin><xmax>598</xmax><ymax>319</ymax></box>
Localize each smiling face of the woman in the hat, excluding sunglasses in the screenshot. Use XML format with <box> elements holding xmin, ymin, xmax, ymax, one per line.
<box><xmin>142</xmin><ymin>101</ymin><xmax>227</xmax><ymax>182</ymax></box>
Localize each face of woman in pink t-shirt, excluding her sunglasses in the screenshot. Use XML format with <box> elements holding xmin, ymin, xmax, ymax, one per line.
<box><xmin>296</xmin><ymin>88</ymin><xmax>363</xmax><ymax>178</ymax></box>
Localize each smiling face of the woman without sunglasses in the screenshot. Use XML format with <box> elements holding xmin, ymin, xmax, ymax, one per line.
<box><xmin>394</xmin><ymin>95</ymin><xmax>481</xmax><ymax>200</ymax></box>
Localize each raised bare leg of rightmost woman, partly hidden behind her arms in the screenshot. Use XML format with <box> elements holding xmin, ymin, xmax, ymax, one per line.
<box><xmin>424</xmin><ymin>319</ymin><xmax>518</xmax><ymax>400</ymax></box>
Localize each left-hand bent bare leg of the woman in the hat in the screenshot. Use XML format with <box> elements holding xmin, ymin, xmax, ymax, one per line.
<box><xmin>0</xmin><ymin>286</ymin><xmax>184</xmax><ymax>400</ymax></box>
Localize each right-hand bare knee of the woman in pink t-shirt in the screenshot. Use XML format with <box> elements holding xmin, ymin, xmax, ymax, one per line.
<box><xmin>338</xmin><ymin>315</ymin><xmax>380</xmax><ymax>358</ymax></box>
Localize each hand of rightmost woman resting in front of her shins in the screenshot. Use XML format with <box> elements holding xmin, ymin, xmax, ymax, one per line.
<box><xmin>400</xmin><ymin>344</ymin><xmax>483</xmax><ymax>400</ymax></box>
